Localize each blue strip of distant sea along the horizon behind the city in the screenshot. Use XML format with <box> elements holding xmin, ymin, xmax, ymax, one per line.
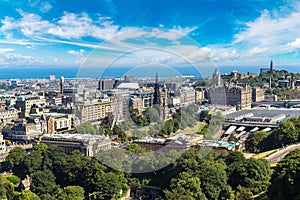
<box><xmin>0</xmin><ymin>66</ymin><xmax>300</xmax><ymax>79</ymax></box>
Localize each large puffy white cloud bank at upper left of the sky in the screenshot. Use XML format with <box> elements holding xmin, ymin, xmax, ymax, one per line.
<box><xmin>0</xmin><ymin>9</ymin><xmax>119</xmax><ymax>40</ymax></box>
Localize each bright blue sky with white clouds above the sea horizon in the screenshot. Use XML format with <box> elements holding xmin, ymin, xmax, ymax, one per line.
<box><xmin>0</xmin><ymin>0</ymin><xmax>300</xmax><ymax>70</ymax></box>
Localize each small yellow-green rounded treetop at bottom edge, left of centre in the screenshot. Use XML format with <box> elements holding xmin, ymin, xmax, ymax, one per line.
<box><xmin>58</xmin><ymin>186</ymin><xmax>84</xmax><ymax>200</ymax></box>
